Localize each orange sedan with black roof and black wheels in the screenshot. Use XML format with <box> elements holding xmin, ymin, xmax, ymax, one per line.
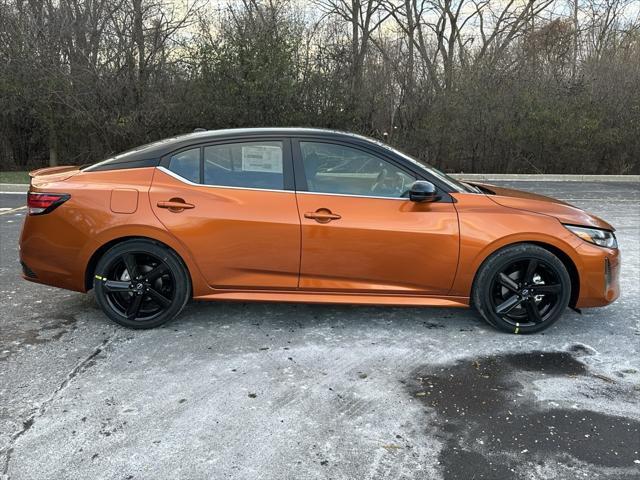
<box><xmin>20</xmin><ymin>128</ymin><xmax>620</xmax><ymax>333</ymax></box>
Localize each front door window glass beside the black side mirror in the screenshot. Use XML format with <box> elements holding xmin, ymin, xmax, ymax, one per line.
<box><xmin>300</xmin><ymin>142</ymin><xmax>415</xmax><ymax>198</ymax></box>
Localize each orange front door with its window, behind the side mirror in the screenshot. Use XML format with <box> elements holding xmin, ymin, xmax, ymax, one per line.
<box><xmin>294</xmin><ymin>140</ymin><xmax>459</xmax><ymax>294</ymax></box>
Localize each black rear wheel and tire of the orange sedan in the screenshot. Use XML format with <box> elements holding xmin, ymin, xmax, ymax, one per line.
<box><xmin>93</xmin><ymin>240</ymin><xmax>191</xmax><ymax>329</ymax></box>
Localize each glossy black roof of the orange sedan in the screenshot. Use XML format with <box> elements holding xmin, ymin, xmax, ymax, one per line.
<box><xmin>85</xmin><ymin>127</ymin><xmax>383</xmax><ymax>171</ymax></box>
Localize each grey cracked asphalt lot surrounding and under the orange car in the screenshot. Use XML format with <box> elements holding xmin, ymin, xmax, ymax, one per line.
<box><xmin>0</xmin><ymin>182</ymin><xmax>640</xmax><ymax>480</ymax></box>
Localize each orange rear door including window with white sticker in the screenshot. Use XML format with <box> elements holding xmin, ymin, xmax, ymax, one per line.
<box><xmin>150</xmin><ymin>138</ymin><xmax>300</xmax><ymax>289</ymax></box>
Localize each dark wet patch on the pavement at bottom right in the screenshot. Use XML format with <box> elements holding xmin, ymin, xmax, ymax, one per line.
<box><xmin>406</xmin><ymin>351</ymin><xmax>640</xmax><ymax>480</ymax></box>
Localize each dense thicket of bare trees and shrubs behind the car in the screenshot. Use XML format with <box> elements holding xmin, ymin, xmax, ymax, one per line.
<box><xmin>0</xmin><ymin>0</ymin><xmax>640</xmax><ymax>173</ymax></box>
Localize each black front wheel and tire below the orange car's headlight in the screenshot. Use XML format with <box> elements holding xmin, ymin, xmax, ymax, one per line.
<box><xmin>471</xmin><ymin>243</ymin><xmax>571</xmax><ymax>334</ymax></box>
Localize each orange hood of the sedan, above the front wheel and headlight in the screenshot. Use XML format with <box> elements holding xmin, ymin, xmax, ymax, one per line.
<box><xmin>474</xmin><ymin>183</ymin><xmax>615</xmax><ymax>231</ymax></box>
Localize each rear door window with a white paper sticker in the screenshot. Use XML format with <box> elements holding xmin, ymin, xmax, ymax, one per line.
<box><xmin>204</xmin><ymin>141</ymin><xmax>284</xmax><ymax>190</ymax></box>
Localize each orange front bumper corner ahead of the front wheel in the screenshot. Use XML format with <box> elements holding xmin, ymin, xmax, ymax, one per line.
<box><xmin>576</xmin><ymin>243</ymin><xmax>620</xmax><ymax>308</ymax></box>
